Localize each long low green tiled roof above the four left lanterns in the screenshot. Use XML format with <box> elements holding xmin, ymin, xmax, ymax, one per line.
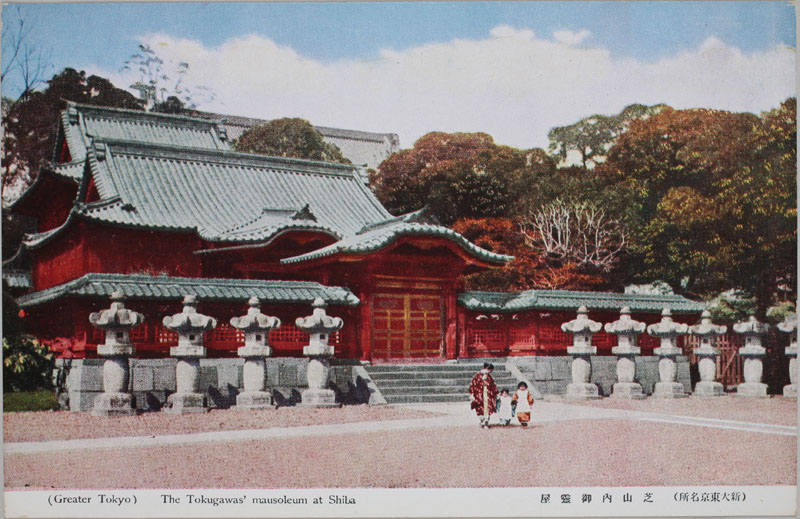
<box><xmin>17</xmin><ymin>274</ymin><xmax>359</xmax><ymax>307</ymax></box>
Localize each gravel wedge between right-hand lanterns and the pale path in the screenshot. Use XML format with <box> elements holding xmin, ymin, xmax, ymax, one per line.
<box><xmin>558</xmin><ymin>395</ymin><xmax>797</xmax><ymax>425</ymax></box>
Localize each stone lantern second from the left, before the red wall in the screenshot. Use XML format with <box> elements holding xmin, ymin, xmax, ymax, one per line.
<box><xmin>162</xmin><ymin>295</ymin><xmax>217</xmax><ymax>414</ymax></box>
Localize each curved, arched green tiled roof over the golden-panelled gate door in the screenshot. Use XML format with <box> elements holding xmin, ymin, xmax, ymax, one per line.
<box><xmin>281</xmin><ymin>213</ymin><xmax>514</xmax><ymax>263</ymax></box>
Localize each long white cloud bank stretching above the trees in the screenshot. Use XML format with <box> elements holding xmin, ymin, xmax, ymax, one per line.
<box><xmin>94</xmin><ymin>26</ymin><xmax>795</xmax><ymax>148</ymax></box>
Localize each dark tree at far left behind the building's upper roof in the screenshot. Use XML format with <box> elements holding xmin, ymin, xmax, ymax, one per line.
<box><xmin>2</xmin><ymin>68</ymin><xmax>142</xmax><ymax>202</ymax></box>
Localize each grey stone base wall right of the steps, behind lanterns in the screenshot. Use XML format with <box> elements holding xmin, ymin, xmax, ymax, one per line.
<box><xmin>507</xmin><ymin>355</ymin><xmax>692</xmax><ymax>396</ymax></box>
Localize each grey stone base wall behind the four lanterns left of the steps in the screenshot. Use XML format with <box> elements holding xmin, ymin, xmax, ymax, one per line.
<box><xmin>54</xmin><ymin>358</ymin><xmax>374</xmax><ymax>411</ymax></box>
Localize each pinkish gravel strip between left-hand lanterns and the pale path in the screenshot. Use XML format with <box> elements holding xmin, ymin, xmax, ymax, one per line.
<box><xmin>3</xmin><ymin>405</ymin><xmax>437</xmax><ymax>442</ymax></box>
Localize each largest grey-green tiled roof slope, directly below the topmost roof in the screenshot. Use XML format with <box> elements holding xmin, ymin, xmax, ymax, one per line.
<box><xmin>28</xmin><ymin>141</ymin><xmax>390</xmax><ymax>246</ymax></box>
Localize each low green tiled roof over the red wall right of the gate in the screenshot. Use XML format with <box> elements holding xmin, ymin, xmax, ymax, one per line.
<box><xmin>458</xmin><ymin>290</ymin><xmax>705</xmax><ymax>314</ymax></box>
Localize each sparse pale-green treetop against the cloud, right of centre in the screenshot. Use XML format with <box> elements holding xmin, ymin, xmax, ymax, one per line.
<box><xmin>547</xmin><ymin>104</ymin><xmax>667</xmax><ymax>169</ymax></box>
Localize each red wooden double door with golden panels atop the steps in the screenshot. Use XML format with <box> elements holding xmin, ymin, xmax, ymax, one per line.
<box><xmin>371</xmin><ymin>293</ymin><xmax>444</xmax><ymax>359</ymax></box>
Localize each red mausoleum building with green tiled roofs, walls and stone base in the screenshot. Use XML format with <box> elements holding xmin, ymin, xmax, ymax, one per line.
<box><xmin>12</xmin><ymin>104</ymin><xmax>703</xmax><ymax>409</ymax></box>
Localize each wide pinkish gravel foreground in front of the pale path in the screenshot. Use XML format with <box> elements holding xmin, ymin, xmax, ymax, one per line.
<box><xmin>5</xmin><ymin>420</ymin><xmax>797</xmax><ymax>489</ymax></box>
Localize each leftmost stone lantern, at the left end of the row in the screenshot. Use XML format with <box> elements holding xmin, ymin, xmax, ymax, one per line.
<box><xmin>89</xmin><ymin>291</ymin><xmax>144</xmax><ymax>416</ymax></box>
